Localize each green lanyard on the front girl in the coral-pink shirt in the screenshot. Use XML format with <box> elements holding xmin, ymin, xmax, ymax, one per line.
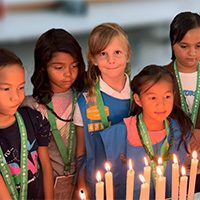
<box><xmin>138</xmin><ymin>113</ymin><xmax>170</xmax><ymax>185</ymax></box>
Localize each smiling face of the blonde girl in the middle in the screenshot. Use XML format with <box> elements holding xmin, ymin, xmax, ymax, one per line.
<box><xmin>95</xmin><ymin>36</ymin><xmax>128</xmax><ymax>81</ymax></box>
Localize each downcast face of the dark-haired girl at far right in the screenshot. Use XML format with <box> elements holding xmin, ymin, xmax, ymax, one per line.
<box><xmin>173</xmin><ymin>27</ymin><xmax>200</xmax><ymax>73</ymax></box>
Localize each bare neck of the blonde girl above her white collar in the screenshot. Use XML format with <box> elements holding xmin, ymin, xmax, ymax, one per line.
<box><xmin>102</xmin><ymin>74</ymin><xmax>126</xmax><ymax>92</ymax></box>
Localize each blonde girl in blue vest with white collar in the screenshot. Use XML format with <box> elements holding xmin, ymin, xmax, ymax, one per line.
<box><xmin>74</xmin><ymin>23</ymin><xmax>131</xmax><ymax>199</ymax></box>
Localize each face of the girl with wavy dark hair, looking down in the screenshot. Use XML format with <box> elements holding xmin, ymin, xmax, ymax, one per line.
<box><xmin>47</xmin><ymin>52</ymin><xmax>78</xmax><ymax>93</ymax></box>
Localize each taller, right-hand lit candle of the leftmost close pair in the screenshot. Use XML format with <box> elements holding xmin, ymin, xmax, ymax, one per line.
<box><xmin>105</xmin><ymin>162</ymin><xmax>113</xmax><ymax>200</ymax></box>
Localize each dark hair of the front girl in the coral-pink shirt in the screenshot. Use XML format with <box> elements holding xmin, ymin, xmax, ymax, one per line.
<box><xmin>131</xmin><ymin>65</ymin><xmax>192</xmax><ymax>149</ymax></box>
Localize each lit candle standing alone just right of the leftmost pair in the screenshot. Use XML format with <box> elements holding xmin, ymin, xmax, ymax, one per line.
<box><xmin>126</xmin><ymin>159</ymin><xmax>135</xmax><ymax>200</ymax></box>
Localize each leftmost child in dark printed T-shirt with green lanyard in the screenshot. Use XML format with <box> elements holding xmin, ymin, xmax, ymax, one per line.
<box><xmin>0</xmin><ymin>49</ymin><xmax>53</xmax><ymax>199</ymax></box>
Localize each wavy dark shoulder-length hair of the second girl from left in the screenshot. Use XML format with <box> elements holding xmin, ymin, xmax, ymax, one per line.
<box><xmin>31</xmin><ymin>28</ymin><xmax>85</xmax><ymax>105</ymax></box>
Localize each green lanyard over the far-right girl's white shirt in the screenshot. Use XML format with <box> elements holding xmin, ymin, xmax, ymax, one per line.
<box><xmin>174</xmin><ymin>61</ymin><xmax>200</xmax><ymax>126</ymax></box>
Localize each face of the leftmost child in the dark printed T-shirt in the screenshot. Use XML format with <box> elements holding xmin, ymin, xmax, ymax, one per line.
<box><xmin>0</xmin><ymin>64</ymin><xmax>25</xmax><ymax>117</ymax></box>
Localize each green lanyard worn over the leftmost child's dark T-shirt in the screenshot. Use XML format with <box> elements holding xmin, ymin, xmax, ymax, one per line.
<box><xmin>0</xmin><ymin>112</ymin><xmax>28</xmax><ymax>200</ymax></box>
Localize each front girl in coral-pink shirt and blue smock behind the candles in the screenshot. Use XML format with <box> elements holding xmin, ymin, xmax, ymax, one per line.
<box><xmin>101</xmin><ymin>65</ymin><xmax>192</xmax><ymax>199</ymax></box>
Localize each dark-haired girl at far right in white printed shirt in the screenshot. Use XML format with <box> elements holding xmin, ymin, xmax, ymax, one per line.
<box><xmin>166</xmin><ymin>12</ymin><xmax>200</xmax><ymax>192</ymax></box>
